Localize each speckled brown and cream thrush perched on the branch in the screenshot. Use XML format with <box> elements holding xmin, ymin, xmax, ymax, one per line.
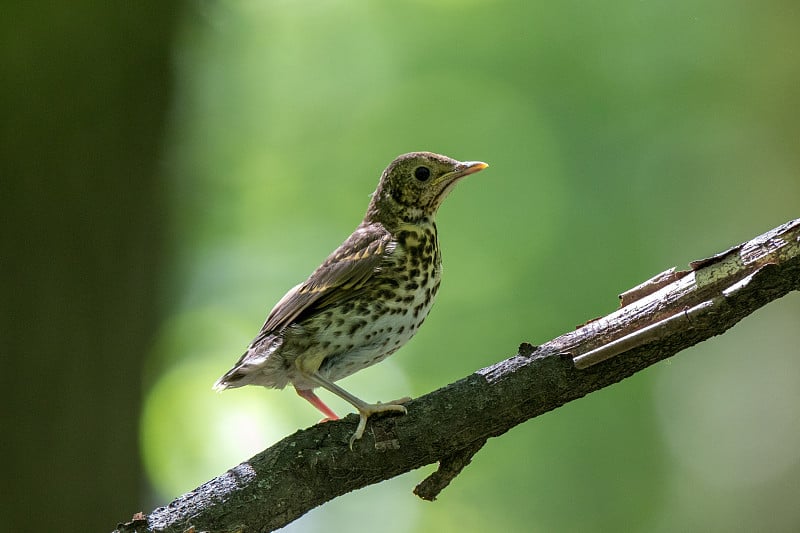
<box><xmin>214</xmin><ymin>152</ymin><xmax>489</xmax><ymax>450</ymax></box>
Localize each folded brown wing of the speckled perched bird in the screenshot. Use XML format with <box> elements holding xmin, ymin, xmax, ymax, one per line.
<box><xmin>254</xmin><ymin>224</ymin><xmax>395</xmax><ymax>342</ymax></box>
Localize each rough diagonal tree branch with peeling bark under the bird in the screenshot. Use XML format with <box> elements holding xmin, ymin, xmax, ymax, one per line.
<box><xmin>117</xmin><ymin>219</ymin><xmax>800</xmax><ymax>533</ymax></box>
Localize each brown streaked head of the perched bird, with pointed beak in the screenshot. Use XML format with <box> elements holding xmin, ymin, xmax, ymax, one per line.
<box><xmin>366</xmin><ymin>152</ymin><xmax>489</xmax><ymax>226</ymax></box>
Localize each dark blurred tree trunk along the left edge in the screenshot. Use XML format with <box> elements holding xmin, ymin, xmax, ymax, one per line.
<box><xmin>0</xmin><ymin>1</ymin><xmax>177</xmax><ymax>531</ymax></box>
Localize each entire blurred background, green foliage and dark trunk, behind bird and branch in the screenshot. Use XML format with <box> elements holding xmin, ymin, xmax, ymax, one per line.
<box><xmin>0</xmin><ymin>0</ymin><xmax>800</xmax><ymax>533</ymax></box>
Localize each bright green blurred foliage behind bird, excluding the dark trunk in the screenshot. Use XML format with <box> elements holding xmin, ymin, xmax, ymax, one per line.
<box><xmin>142</xmin><ymin>0</ymin><xmax>800</xmax><ymax>532</ymax></box>
